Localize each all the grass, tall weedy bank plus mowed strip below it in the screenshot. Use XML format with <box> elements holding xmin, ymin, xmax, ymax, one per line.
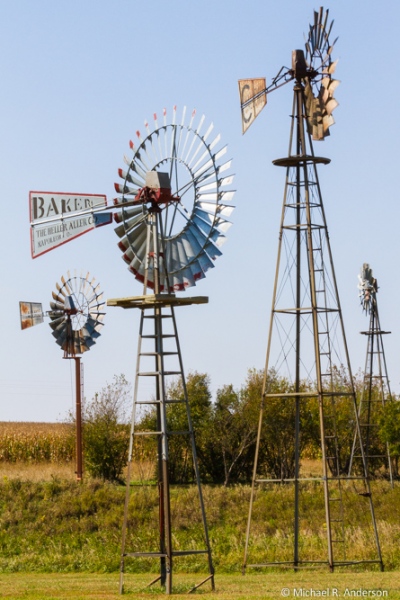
<box><xmin>0</xmin><ymin>464</ymin><xmax>400</xmax><ymax>600</ymax></box>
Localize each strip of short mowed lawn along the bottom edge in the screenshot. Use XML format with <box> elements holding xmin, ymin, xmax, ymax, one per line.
<box><xmin>0</xmin><ymin>571</ymin><xmax>400</xmax><ymax>600</ymax></box>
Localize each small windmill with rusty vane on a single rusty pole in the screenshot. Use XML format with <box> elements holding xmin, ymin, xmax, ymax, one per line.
<box><xmin>19</xmin><ymin>271</ymin><xmax>105</xmax><ymax>481</ymax></box>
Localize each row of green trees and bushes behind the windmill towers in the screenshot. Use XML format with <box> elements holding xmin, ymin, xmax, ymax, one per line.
<box><xmin>83</xmin><ymin>368</ymin><xmax>400</xmax><ymax>486</ymax></box>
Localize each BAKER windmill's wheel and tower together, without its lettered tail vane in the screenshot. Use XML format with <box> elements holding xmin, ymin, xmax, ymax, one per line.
<box><xmin>107</xmin><ymin>107</ymin><xmax>233</xmax><ymax>594</ymax></box>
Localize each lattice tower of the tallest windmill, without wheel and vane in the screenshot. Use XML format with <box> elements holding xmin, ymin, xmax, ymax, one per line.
<box><xmin>243</xmin><ymin>82</ymin><xmax>382</xmax><ymax>572</ymax></box>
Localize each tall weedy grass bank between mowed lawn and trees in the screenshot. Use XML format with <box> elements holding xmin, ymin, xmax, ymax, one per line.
<box><xmin>0</xmin><ymin>477</ymin><xmax>400</xmax><ymax>574</ymax></box>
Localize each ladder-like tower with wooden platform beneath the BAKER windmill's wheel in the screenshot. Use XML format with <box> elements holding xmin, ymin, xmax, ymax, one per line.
<box><xmin>115</xmin><ymin>209</ymin><xmax>214</xmax><ymax>594</ymax></box>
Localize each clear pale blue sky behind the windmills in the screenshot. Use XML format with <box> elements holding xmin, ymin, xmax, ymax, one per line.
<box><xmin>0</xmin><ymin>0</ymin><xmax>400</xmax><ymax>421</ymax></box>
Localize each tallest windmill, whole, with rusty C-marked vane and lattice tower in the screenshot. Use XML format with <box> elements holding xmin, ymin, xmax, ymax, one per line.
<box><xmin>239</xmin><ymin>8</ymin><xmax>383</xmax><ymax>571</ymax></box>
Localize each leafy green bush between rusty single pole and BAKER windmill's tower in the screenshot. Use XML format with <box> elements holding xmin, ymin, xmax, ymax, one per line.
<box><xmin>83</xmin><ymin>374</ymin><xmax>131</xmax><ymax>481</ymax></box>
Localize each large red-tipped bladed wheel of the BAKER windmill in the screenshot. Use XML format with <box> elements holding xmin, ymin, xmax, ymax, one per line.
<box><xmin>114</xmin><ymin>107</ymin><xmax>234</xmax><ymax>291</ymax></box>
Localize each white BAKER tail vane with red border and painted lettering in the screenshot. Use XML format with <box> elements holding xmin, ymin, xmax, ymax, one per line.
<box><xmin>29</xmin><ymin>192</ymin><xmax>112</xmax><ymax>258</ymax></box>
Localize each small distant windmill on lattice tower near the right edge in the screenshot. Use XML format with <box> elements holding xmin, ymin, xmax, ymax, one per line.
<box><xmin>349</xmin><ymin>263</ymin><xmax>393</xmax><ymax>487</ymax></box>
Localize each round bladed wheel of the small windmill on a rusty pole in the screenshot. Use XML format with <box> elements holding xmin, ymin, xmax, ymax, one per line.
<box><xmin>49</xmin><ymin>272</ymin><xmax>105</xmax><ymax>357</ymax></box>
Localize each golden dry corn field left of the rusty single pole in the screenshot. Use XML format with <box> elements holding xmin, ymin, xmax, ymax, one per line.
<box><xmin>0</xmin><ymin>422</ymin><xmax>75</xmax><ymax>464</ymax></box>
